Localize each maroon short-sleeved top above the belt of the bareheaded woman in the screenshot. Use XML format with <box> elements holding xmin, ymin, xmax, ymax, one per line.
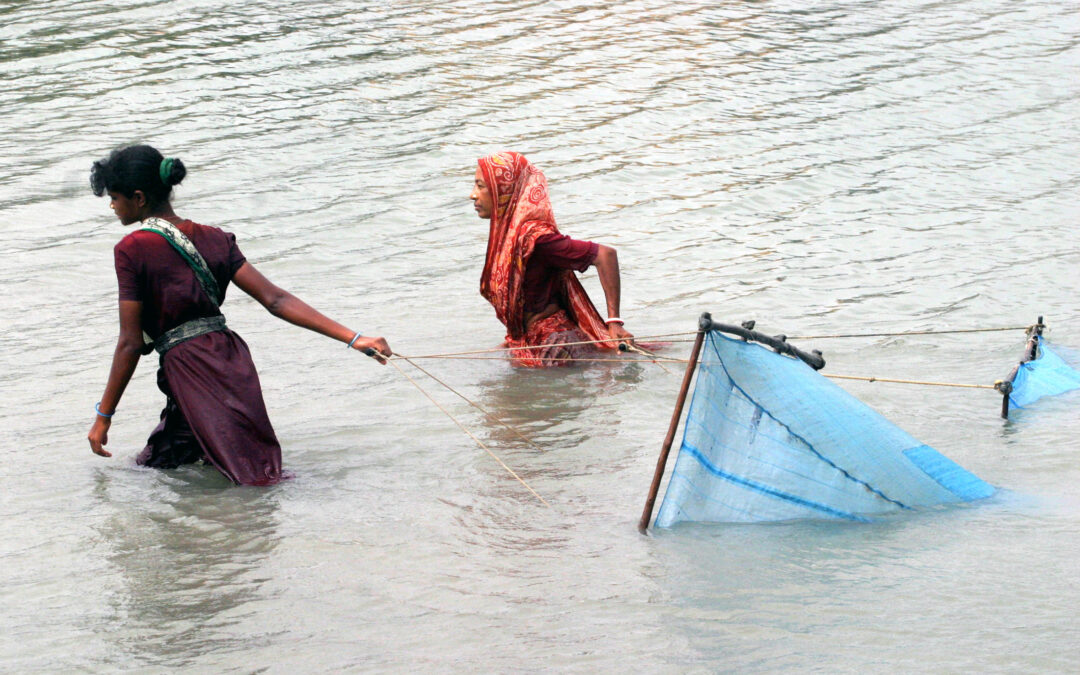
<box><xmin>112</xmin><ymin>220</ymin><xmax>246</xmax><ymax>338</ymax></box>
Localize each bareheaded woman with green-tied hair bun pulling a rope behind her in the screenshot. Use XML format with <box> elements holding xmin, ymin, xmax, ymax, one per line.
<box><xmin>87</xmin><ymin>146</ymin><xmax>391</xmax><ymax>485</ymax></box>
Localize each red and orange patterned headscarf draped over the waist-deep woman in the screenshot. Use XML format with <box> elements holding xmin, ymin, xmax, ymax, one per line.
<box><xmin>477</xmin><ymin>151</ymin><xmax>608</xmax><ymax>347</ymax></box>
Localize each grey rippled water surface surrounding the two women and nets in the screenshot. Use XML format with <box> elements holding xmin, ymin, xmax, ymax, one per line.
<box><xmin>0</xmin><ymin>0</ymin><xmax>1080</xmax><ymax>672</ymax></box>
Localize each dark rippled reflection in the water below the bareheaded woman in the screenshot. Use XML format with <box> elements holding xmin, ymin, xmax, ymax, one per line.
<box><xmin>93</xmin><ymin>465</ymin><xmax>280</xmax><ymax>666</ymax></box>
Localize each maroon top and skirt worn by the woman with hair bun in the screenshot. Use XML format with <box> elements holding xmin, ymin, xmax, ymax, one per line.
<box><xmin>114</xmin><ymin>220</ymin><xmax>282</xmax><ymax>485</ymax></box>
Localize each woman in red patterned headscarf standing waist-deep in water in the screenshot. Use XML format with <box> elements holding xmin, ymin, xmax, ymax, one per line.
<box><xmin>469</xmin><ymin>152</ymin><xmax>634</xmax><ymax>368</ymax></box>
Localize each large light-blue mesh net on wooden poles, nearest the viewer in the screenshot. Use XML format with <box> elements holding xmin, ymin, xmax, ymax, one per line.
<box><xmin>656</xmin><ymin>332</ymin><xmax>994</xmax><ymax>527</ymax></box>
